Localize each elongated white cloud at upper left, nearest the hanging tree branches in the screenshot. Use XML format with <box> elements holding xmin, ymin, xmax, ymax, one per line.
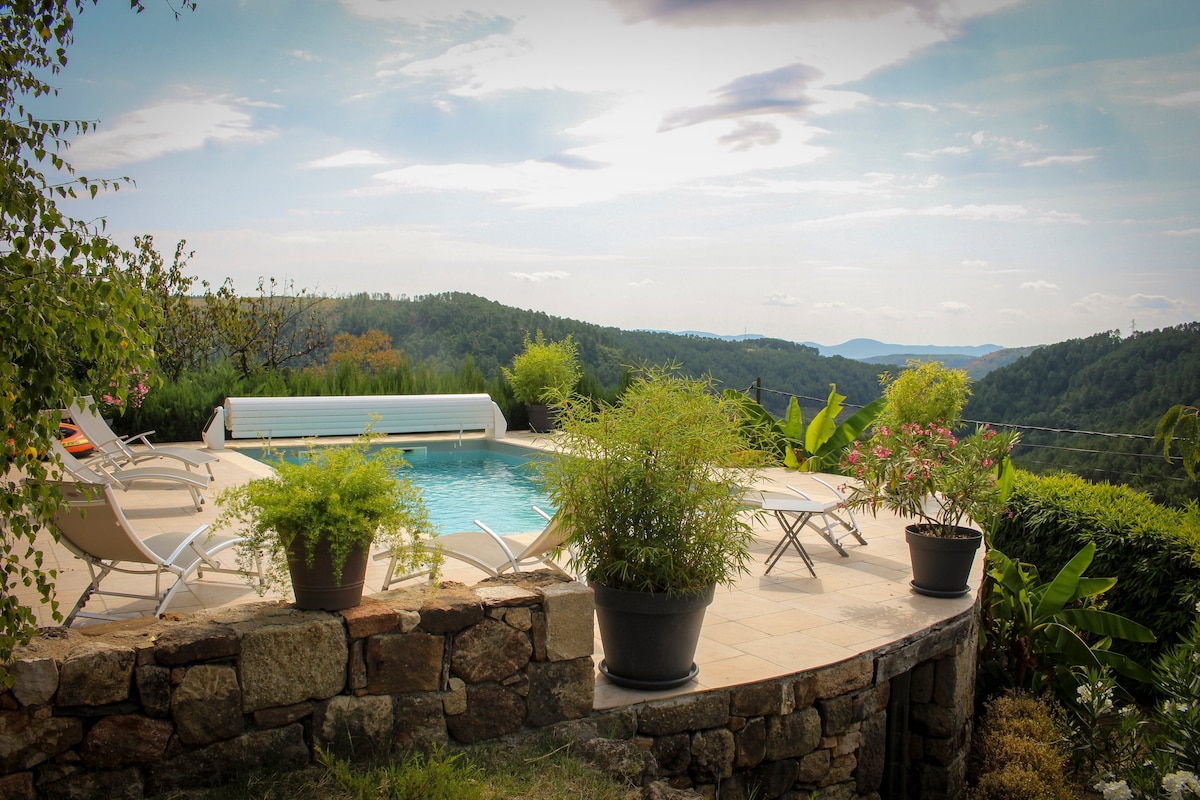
<box><xmin>68</xmin><ymin>97</ymin><xmax>275</xmax><ymax>169</ymax></box>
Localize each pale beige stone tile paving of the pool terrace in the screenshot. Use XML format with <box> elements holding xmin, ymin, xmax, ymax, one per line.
<box><xmin>11</xmin><ymin>432</ymin><xmax>982</xmax><ymax>709</ymax></box>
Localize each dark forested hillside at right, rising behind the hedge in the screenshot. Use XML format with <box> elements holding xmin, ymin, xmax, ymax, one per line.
<box><xmin>966</xmin><ymin>323</ymin><xmax>1200</xmax><ymax>504</ymax></box>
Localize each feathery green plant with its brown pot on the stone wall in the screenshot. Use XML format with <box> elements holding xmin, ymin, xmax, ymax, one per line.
<box><xmin>216</xmin><ymin>429</ymin><xmax>437</xmax><ymax>610</ymax></box>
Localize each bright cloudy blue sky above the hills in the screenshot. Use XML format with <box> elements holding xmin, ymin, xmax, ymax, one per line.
<box><xmin>37</xmin><ymin>0</ymin><xmax>1200</xmax><ymax>347</ymax></box>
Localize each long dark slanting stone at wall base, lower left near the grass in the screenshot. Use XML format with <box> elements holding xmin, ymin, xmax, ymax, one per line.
<box><xmin>145</xmin><ymin>724</ymin><xmax>309</xmax><ymax>796</ymax></box>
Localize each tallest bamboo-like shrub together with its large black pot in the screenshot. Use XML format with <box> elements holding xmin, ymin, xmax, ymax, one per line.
<box><xmin>538</xmin><ymin>367</ymin><xmax>757</xmax><ymax>688</ymax></box>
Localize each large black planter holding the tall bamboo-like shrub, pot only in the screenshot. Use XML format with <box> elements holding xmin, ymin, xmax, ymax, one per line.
<box><xmin>592</xmin><ymin>585</ymin><xmax>715</xmax><ymax>690</ymax></box>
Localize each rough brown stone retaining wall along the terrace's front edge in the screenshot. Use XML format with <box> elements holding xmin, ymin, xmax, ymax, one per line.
<box><xmin>0</xmin><ymin>573</ymin><xmax>977</xmax><ymax>800</ymax></box>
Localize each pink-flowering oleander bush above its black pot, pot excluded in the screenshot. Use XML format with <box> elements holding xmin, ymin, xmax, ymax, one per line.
<box><xmin>842</xmin><ymin>422</ymin><xmax>1018</xmax><ymax>536</ymax></box>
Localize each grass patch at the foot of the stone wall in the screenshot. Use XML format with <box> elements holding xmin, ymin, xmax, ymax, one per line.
<box><xmin>164</xmin><ymin>739</ymin><xmax>641</xmax><ymax>800</ymax></box>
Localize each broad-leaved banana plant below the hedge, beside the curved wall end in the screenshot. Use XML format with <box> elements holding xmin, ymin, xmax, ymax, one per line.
<box><xmin>979</xmin><ymin>543</ymin><xmax>1154</xmax><ymax>697</ymax></box>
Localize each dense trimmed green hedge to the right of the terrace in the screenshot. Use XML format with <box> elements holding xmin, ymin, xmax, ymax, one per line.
<box><xmin>991</xmin><ymin>471</ymin><xmax>1200</xmax><ymax>663</ymax></box>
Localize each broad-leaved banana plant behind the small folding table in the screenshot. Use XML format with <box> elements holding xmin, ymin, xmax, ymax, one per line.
<box><xmin>725</xmin><ymin>384</ymin><xmax>884</xmax><ymax>473</ymax></box>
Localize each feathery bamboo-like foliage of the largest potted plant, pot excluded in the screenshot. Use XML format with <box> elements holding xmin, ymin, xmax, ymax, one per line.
<box><xmin>538</xmin><ymin>367</ymin><xmax>757</xmax><ymax>594</ymax></box>
